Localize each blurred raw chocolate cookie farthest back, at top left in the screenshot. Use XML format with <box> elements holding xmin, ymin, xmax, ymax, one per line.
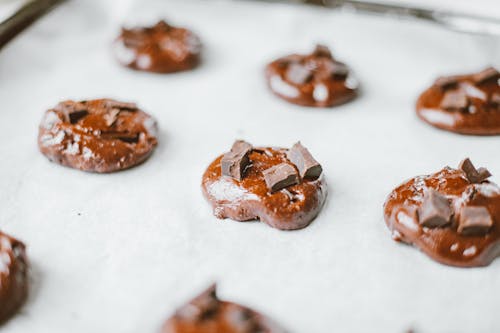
<box><xmin>113</xmin><ymin>21</ymin><xmax>201</xmax><ymax>73</ymax></box>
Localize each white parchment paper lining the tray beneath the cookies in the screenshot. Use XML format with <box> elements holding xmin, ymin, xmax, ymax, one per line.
<box><xmin>0</xmin><ymin>0</ymin><xmax>500</xmax><ymax>333</ymax></box>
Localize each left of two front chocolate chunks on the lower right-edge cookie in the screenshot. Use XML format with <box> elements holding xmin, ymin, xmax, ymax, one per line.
<box><xmin>418</xmin><ymin>190</ymin><xmax>453</xmax><ymax>228</ymax></box>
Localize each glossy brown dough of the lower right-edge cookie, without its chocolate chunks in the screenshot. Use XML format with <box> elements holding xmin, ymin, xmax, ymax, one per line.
<box><xmin>384</xmin><ymin>167</ymin><xmax>500</xmax><ymax>267</ymax></box>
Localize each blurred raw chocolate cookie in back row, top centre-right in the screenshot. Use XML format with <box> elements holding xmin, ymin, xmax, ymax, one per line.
<box><xmin>266</xmin><ymin>45</ymin><xmax>358</xmax><ymax>107</ymax></box>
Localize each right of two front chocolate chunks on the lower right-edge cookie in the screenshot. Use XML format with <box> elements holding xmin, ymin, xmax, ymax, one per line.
<box><xmin>458</xmin><ymin>206</ymin><xmax>493</xmax><ymax>236</ymax></box>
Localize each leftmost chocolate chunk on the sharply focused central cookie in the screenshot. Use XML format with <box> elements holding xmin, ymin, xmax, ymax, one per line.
<box><xmin>221</xmin><ymin>140</ymin><xmax>252</xmax><ymax>181</ymax></box>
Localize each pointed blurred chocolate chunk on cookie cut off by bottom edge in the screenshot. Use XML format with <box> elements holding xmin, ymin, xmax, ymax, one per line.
<box><xmin>176</xmin><ymin>284</ymin><xmax>219</xmax><ymax>321</ymax></box>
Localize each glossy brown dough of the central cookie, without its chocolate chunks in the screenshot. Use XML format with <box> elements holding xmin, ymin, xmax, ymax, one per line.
<box><xmin>202</xmin><ymin>148</ymin><xmax>327</xmax><ymax>230</ymax></box>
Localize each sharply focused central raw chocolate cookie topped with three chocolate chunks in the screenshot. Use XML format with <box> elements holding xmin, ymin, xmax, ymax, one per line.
<box><xmin>202</xmin><ymin>141</ymin><xmax>327</xmax><ymax>230</ymax></box>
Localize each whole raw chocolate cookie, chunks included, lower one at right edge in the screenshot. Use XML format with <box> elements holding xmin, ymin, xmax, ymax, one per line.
<box><xmin>384</xmin><ymin>159</ymin><xmax>500</xmax><ymax>267</ymax></box>
